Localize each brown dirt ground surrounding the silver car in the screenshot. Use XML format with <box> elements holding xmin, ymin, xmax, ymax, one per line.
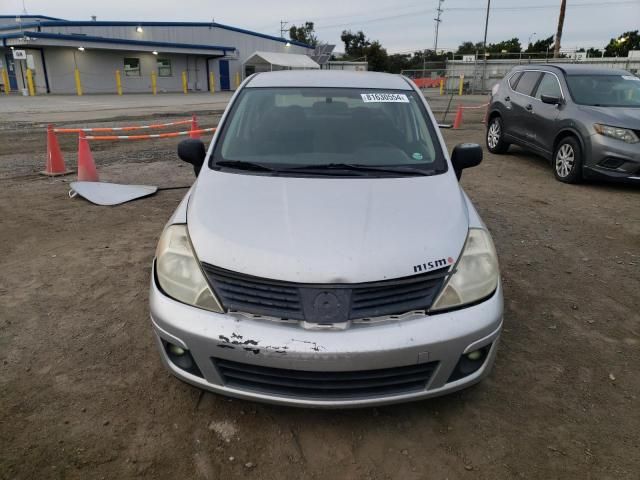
<box><xmin>0</xmin><ymin>100</ymin><xmax>640</xmax><ymax>480</ymax></box>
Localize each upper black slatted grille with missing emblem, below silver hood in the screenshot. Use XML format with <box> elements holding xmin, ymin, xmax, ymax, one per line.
<box><xmin>203</xmin><ymin>264</ymin><xmax>449</xmax><ymax>324</ymax></box>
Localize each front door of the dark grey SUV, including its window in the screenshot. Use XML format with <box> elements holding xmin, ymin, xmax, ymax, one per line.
<box><xmin>528</xmin><ymin>72</ymin><xmax>564</xmax><ymax>157</ymax></box>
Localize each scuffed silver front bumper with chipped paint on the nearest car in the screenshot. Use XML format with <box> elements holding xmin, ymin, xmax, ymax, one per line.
<box><xmin>149</xmin><ymin>264</ymin><xmax>503</xmax><ymax>408</ymax></box>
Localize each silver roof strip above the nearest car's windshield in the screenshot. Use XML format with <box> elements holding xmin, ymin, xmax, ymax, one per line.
<box><xmin>246</xmin><ymin>70</ymin><xmax>412</xmax><ymax>90</ymax></box>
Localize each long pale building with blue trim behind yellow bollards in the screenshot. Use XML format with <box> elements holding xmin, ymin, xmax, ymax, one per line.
<box><xmin>0</xmin><ymin>16</ymin><xmax>313</xmax><ymax>94</ymax></box>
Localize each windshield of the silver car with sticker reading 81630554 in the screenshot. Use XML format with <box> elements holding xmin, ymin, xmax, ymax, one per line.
<box><xmin>210</xmin><ymin>88</ymin><xmax>446</xmax><ymax>176</ymax></box>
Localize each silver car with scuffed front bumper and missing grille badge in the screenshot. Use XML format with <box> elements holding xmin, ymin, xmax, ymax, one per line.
<box><xmin>150</xmin><ymin>71</ymin><xmax>503</xmax><ymax>407</ymax></box>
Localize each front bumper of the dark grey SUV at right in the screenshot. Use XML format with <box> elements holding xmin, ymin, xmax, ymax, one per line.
<box><xmin>584</xmin><ymin>134</ymin><xmax>640</xmax><ymax>182</ymax></box>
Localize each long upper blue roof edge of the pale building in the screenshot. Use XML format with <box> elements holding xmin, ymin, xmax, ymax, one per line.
<box><xmin>0</xmin><ymin>15</ymin><xmax>314</xmax><ymax>48</ymax></box>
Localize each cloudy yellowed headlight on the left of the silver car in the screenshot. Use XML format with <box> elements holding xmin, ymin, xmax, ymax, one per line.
<box><xmin>156</xmin><ymin>225</ymin><xmax>224</xmax><ymax>313</ymax></box>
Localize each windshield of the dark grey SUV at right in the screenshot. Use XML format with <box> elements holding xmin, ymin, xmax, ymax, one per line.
<box><xmin>567</xmin><ymin>74</ymin><xmax>640</xmax><ymax>107</ymax></box>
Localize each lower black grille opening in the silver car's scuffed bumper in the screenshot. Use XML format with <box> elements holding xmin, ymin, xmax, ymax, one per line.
<box><xmin>212</xmin><ymin>358</ymin><xmax>438</xmax><ymax>400</ymax></box>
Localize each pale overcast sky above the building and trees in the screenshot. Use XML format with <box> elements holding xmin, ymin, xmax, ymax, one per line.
<box><xmin>0</xmin><ymin>0</ymin><xmax>640</xmax><ymax>53</ymax></box>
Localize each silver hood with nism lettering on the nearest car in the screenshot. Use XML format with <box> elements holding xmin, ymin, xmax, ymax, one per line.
<box><xmin>187</xmin><ymin>170</ymin><xmax>469</xmax><ymax>283</ymax></box>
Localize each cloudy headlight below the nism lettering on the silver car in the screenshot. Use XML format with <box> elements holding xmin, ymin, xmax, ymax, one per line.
<box><xmin>431</xmin><ymin>228</ymin><xmax>500</xmax><ymax>311</ymax></box>
